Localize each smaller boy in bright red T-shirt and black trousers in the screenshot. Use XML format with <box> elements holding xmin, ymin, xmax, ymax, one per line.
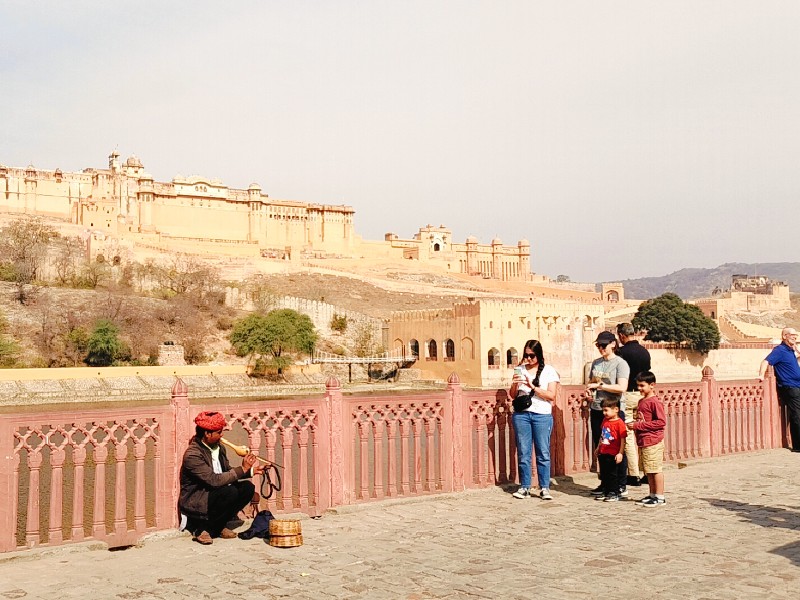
<box><xmin>595</xmin><ymin>398</ymin><xmax>628</xmax><ymax>502</ymax></box>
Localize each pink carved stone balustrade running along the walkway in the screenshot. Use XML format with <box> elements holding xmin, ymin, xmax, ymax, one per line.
<box><xmin>0</xmin><ymin>369</ymin><xmax>786</xmax><ymax>551</ymax></box>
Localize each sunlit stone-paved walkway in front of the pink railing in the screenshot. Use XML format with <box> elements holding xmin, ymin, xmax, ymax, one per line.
<box><xmin>0</xmin><ymin>450</ymin><xmax>800</xmax><ymax>600</ymax></box>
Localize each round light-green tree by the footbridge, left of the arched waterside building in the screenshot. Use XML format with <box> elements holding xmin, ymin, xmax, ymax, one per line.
<box><xmin>230</xmin><ymin>308</ymin><xmax>317</xmax><ymax>374</ymax></box>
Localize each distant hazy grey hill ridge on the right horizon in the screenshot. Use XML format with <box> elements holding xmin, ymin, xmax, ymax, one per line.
<box><xmin>622</xmin><ymin>262</ymin><xmax>800</xmax><ymax>300</ymax></box>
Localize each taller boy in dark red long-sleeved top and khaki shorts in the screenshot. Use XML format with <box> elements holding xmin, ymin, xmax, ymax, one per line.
<box><xmin>628</xmin><ymin>371</ymin><xmax>667</xmax><ymax>506</ymax></box>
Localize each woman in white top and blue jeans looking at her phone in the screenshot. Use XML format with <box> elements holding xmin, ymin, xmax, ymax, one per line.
<box><xmin>509</xmin><ymin>340</ymin><xmax>559</xmax><ymax>500</ymax></box>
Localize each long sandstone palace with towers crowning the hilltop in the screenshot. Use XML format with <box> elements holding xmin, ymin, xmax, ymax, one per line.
<box><xmin>0</xmin><ymin>152</ymin><xmax>531</xmax><ymax>281</ymax></box>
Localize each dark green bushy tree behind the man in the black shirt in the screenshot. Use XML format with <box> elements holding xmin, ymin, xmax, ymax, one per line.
<box><xmin>632</xmin><ymin>293</ymin><xmax>720</xmax><ymax>354</ymax></box>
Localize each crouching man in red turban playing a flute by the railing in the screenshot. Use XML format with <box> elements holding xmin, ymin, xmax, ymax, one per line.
<box><xmin>178</xmin><ymin>412</ymin><xmax>264</xmax><ymax>544</ymax></box>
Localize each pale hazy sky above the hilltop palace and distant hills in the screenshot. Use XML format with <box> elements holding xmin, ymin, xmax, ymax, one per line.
<box><xmin>0</xmin><ymin>0</ymin><xmax>800</xmax><ymax>281</ymax></box>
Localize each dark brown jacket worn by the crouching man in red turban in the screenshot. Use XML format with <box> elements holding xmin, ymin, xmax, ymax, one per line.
<box><xmin>178</xmin><ymin>437</ymin><xmax>249</xmax><ymax>519</ymax></box>
